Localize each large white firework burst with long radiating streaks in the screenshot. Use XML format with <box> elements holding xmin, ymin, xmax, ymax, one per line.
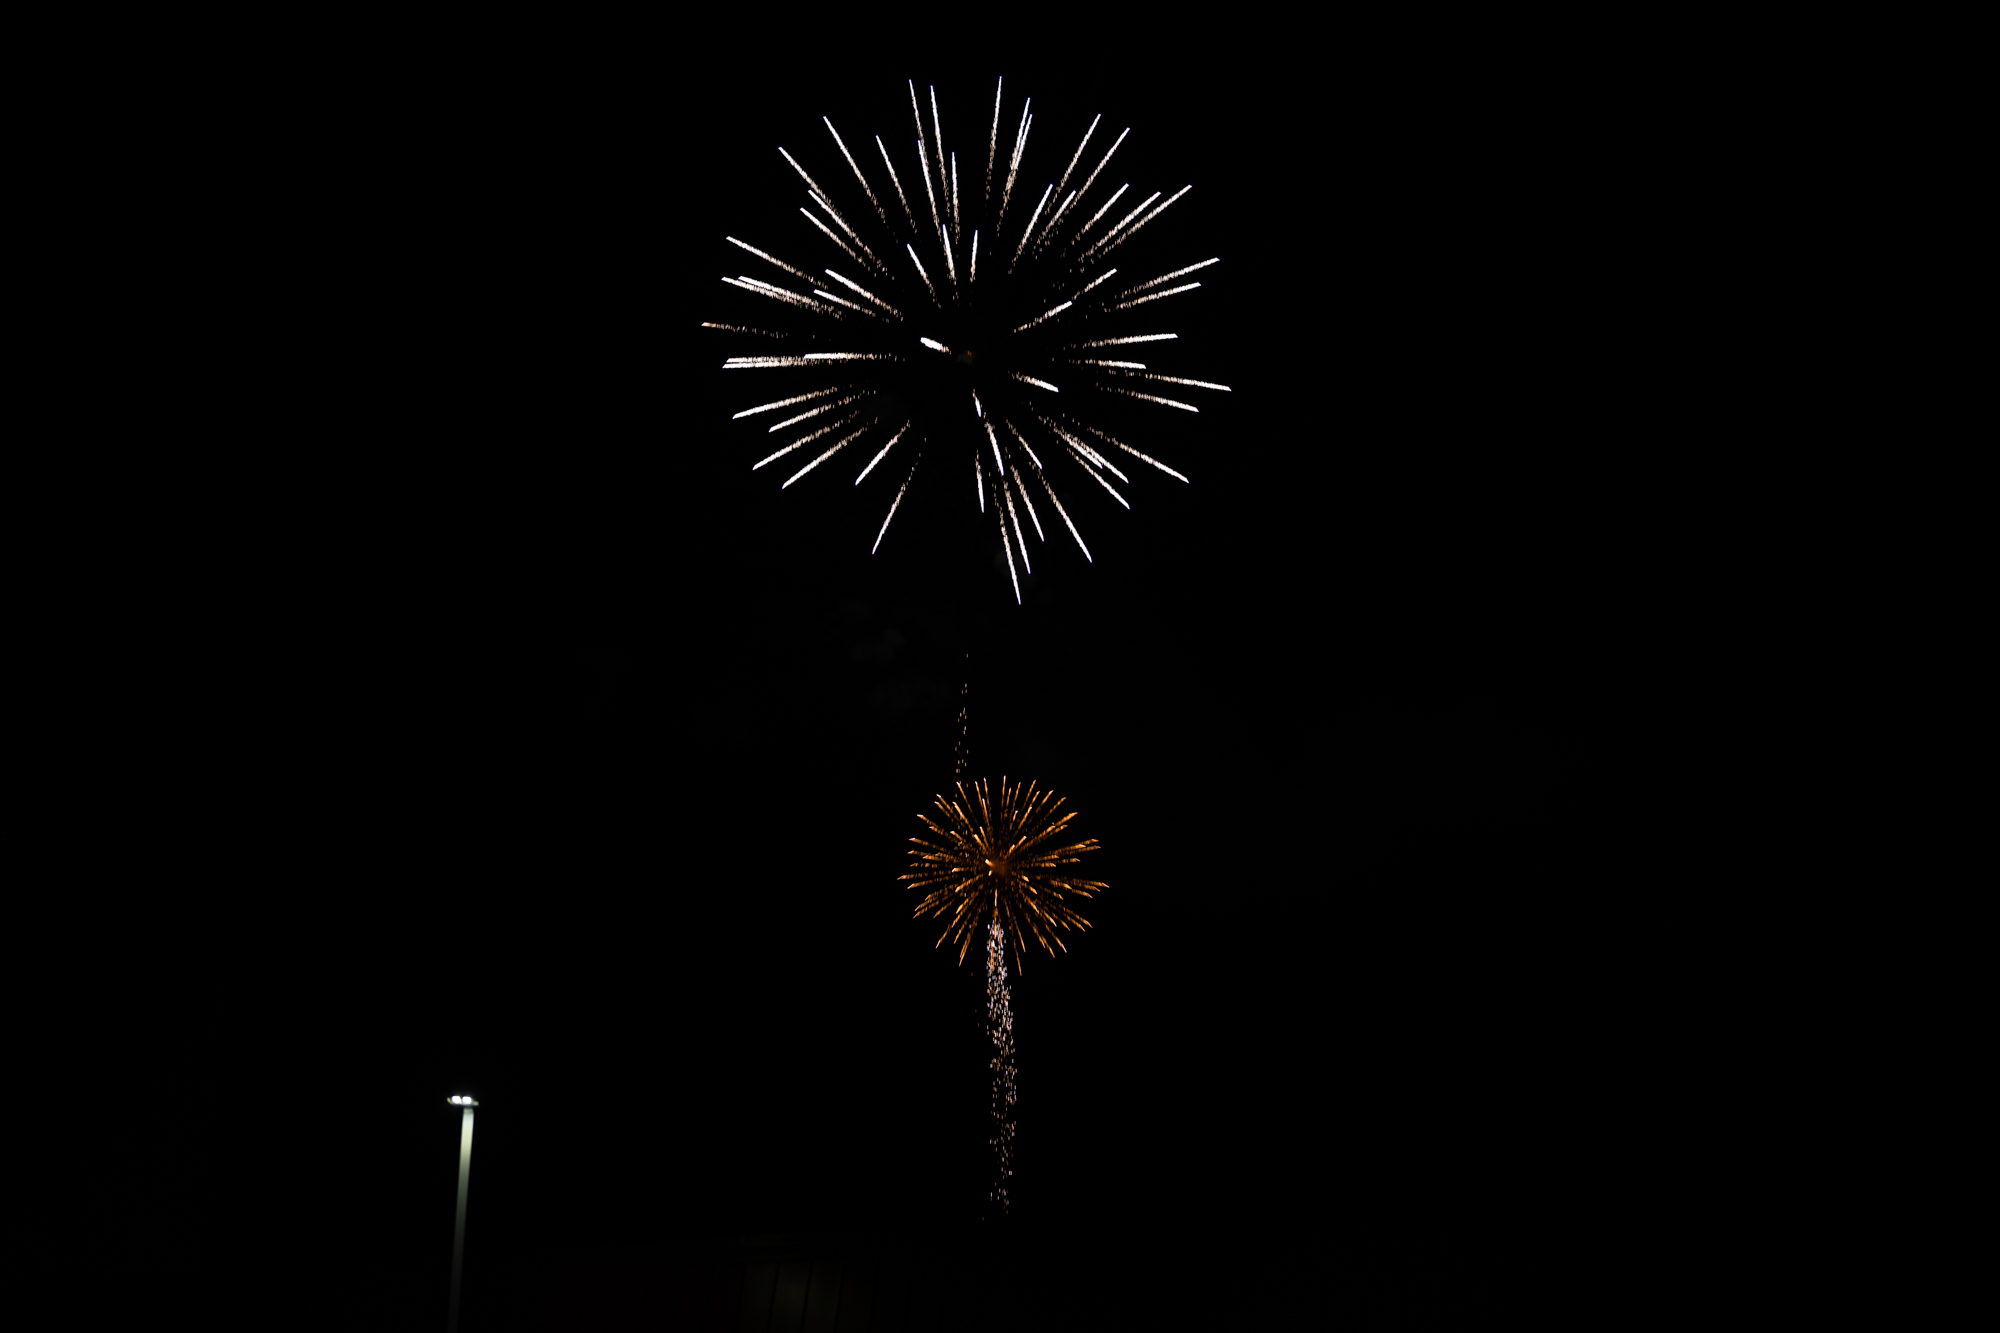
<box><xmin>704</xmin><ymin>78</ymin><xmax>1230</xmax><ymax>602</ymax></box>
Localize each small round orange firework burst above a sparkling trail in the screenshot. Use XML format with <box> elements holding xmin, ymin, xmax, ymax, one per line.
<box><xmin>902</xmin><ymin>779</ymin><xmax>1108</xmax><ymax>967</ymax></box>
